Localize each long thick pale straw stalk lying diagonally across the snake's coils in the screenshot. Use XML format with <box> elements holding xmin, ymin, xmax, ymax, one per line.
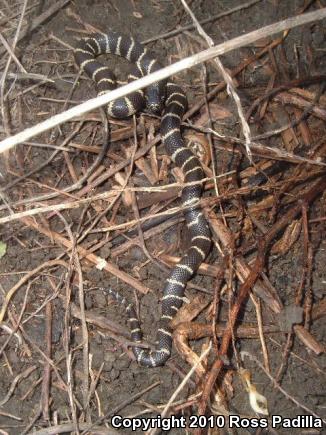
<box><xmin>0</xmin><ymin>8</ymin><xmax>326</xmax><ymax>152</ymax></box>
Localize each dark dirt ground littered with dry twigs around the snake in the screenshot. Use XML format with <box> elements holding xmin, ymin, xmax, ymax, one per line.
<box><xmin>0</xmin><ymin>0</ymin><xmax>326</xmax><ymax>435</ymax></box>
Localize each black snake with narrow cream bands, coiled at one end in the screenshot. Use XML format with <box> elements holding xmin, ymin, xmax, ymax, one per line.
<box><xmin>74</xmin><ymin>32</ymin><xmax>211</xmax><ymax>367</ymax></box>
